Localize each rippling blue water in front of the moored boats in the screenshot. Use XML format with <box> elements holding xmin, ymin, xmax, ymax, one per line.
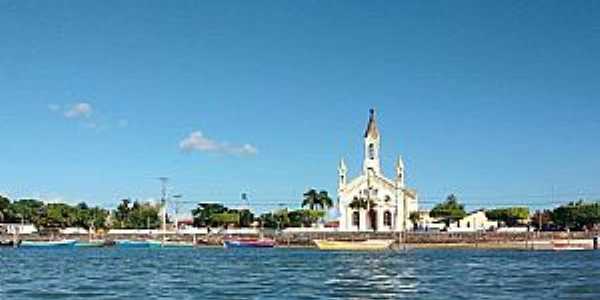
<box><xmin>0</xmin><ymin>248</ymin><xmax>600</xmax><ymax>300</ymax></box>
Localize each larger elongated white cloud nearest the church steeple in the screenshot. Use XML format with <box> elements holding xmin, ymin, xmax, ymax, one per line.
<box><xmin>179</xmin><ymin>131</ymin><xmax>258</xmax><ymax>156</ymax></box>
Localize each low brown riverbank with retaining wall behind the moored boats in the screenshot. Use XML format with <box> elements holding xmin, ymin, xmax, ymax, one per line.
<box><xmin>0</xmin><ymin>231</ymin><xmax>600</xmax><ymax>250</ymax></box>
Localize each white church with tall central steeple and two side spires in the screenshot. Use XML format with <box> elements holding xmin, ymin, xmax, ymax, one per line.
<box><xmin>338</xmin><ymin>109</ymin><xmax>418</xmax><ymax>232</ymax></box>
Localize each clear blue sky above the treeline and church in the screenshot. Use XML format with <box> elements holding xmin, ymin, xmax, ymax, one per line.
<box><xmin>0</xmin><ymin>0</ymin><xmax>600</xmax><ymax>211</ymax></box>
